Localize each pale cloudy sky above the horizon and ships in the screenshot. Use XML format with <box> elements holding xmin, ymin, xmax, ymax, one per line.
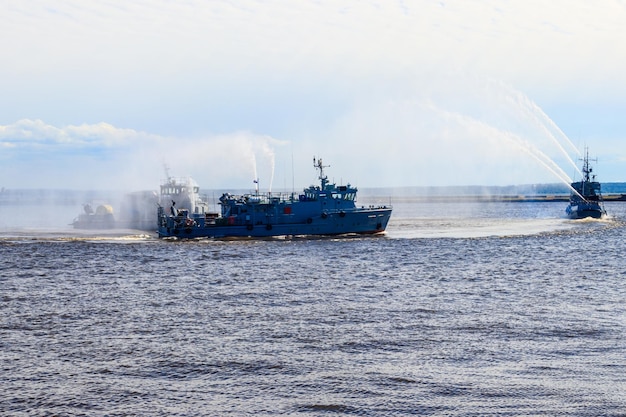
<box><xmin>0</xmin><ymin>0</ymin><xmax>626</xmax><ymax>190</ymax></box>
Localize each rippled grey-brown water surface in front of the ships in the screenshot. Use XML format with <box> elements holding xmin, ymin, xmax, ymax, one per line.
<box><xmin>0</xmin><ymin>203</ymin><xmax>626</xmax><ymax>416</ymax></box>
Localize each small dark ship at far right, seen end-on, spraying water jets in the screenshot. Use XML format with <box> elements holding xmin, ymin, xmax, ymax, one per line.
<box><xmin>565</xmin><ymin>149</ymin><xmax>606</xmax><ymax>219</ymax></box>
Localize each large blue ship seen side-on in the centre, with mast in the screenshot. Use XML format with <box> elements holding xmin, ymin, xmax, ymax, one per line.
<box><xmin>158</xmin><ymin>158</ymin><xmax>392</xmax><ymax>238</ymax></box>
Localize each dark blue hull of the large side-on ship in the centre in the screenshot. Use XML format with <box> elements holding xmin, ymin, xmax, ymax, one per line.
<box><xmin>158</xmin><ymin>208</ymin><xmax>391</xmax><ymax>239</ymax></box>
